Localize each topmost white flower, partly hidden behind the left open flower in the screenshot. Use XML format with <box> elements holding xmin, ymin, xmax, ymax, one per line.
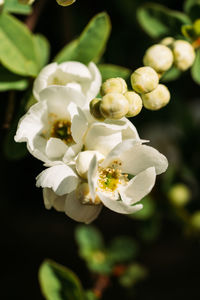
<box><xmin>33</xmin><ymin>61</ymin><xmax>101</xmax><ymax>101</ymax></box>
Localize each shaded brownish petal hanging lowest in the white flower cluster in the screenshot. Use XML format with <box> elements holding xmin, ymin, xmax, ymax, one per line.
<box><xmin>65</xmin><ymin>191</ymin><xmax>102</xmax><ymax>224</ymax></box>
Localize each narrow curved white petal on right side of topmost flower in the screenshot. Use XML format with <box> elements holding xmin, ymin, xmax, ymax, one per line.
<box><xmin>86</xmin><ymin>62</ymin><xmax>102</xmax><ymax>101</ymax></box>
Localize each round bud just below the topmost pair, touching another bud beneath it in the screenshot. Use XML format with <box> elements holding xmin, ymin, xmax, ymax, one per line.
<box><xmin>131</xmin><ymin>67</ymin><xmax>159</xmax><ymax>94</ymax></box>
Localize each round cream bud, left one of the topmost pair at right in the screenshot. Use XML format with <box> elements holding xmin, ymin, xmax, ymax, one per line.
<box><xmin>143</xmin><ymin>44</ymin><xmax>173</xmax><ymax>73</ymax></box>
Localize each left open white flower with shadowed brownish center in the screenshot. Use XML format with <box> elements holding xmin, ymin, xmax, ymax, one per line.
<box><xmin>15</xmin><ymin>87</ymin><xmax>88</xmax><ymax>165</ymax></box>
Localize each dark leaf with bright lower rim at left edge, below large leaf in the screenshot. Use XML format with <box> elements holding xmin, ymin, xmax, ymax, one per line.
<box><xmin>0</xmin><ymin>65</ymin><xmax>28</xmax><ymax>92</ymax></box>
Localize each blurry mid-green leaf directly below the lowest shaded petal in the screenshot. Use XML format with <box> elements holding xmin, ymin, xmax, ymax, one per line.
<box><xmin>75</xmin><ymin>225</ymin><xmax>104</xmax><ymax>254</ymax></box>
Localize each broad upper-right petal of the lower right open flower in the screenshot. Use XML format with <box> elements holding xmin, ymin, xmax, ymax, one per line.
<box><xmin>120</xmin><ymin>144</ymin><xmax>168</xmax><ymax>175</ymax></box>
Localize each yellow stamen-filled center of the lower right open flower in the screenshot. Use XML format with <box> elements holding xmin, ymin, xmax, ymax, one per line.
<box><xmin>98</xmin><ymin>161</ymin><xmax>129</xmax><ymax>192</ymax></box>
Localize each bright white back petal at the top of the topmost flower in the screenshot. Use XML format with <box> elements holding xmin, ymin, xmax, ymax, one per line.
<box><xmin>59</xmin><ymin>61</ymin><xmax>91</xmax><ymax>82</ymax></box>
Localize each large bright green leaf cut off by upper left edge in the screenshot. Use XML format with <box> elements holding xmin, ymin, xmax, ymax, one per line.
<box><xmin>0</xmin><ymin>13</ymin><xmax>38</xmax><ymax>76</ymax></box>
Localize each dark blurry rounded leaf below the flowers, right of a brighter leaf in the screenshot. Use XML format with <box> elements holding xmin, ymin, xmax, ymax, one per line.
<box><xmin>108</xmin><ymin>236</ymin><xmax>138</xmax><ymax>263</ymax></box>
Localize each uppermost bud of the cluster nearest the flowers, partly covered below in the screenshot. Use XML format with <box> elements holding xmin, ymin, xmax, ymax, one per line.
<box><xmin>101</xmin><ymin>77</ymin><xmax>127</xmax><ymax>96</ymax></box>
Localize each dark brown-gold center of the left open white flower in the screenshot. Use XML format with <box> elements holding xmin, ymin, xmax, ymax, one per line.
<box><xmin>51</xmin><ymin>120</ymin><xmax>74</xmax><ymax>144</ymax></box>
